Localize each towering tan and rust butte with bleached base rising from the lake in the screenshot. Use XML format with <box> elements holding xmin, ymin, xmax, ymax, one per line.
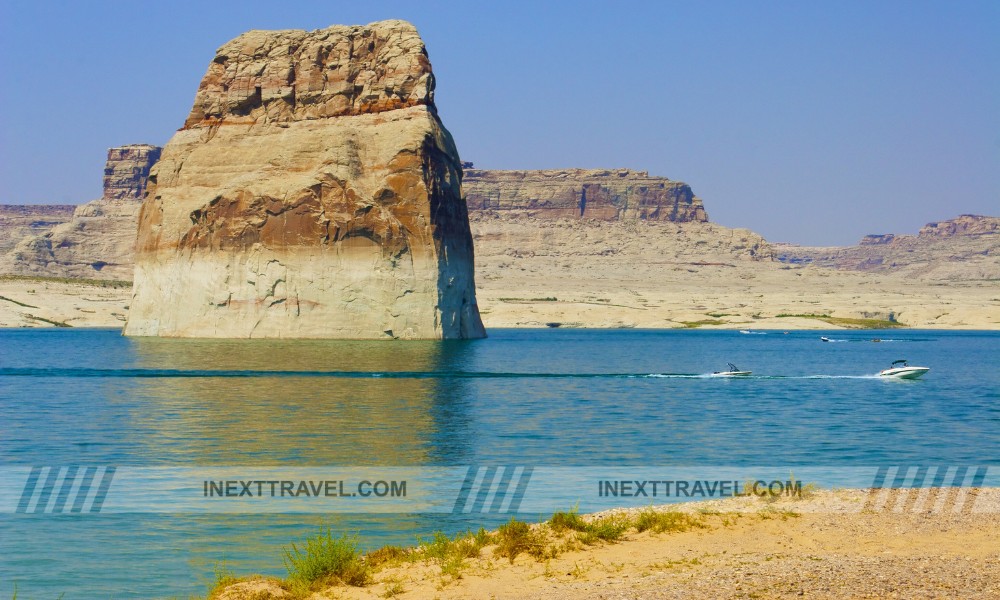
<box><xmin>125</xmin><ymin>21</ymin><xmax>485</xmax><ymax>339</ymax></box>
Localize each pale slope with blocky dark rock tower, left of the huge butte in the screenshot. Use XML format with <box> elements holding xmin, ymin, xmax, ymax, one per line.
<box><xmin>0</xmin><ymin>144</ymin><xmax>160</xmax><ymax>280</ymax></box>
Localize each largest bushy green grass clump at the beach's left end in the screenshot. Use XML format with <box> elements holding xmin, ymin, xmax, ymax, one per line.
<box><xmin>283</xmin><ymin>527</ymin><xmax>371</xmax><ymax>586</ymax></box>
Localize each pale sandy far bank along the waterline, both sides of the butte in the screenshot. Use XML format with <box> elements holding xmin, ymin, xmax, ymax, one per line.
<box><xmin>0</xmin><ymin>274</ymin><xmax>1000</xmax><ymax>331</ymax></box>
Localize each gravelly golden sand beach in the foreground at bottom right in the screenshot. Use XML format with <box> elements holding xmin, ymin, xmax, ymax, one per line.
<box><xmin>213</xmin><ymin>488</ymin><xmax>1000</xmax><ymax>600</ymax></box>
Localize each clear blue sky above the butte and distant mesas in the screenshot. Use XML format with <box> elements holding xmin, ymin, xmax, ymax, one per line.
<box><xmin>0</xmin><ymin>0</ymin><xmax>1000</xmax><ymax>245</ymax></box>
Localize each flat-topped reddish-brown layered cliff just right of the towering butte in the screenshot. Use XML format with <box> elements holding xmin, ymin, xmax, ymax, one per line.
<box><xmin>463</xmin><ymin>169</ymin><xmax>708</xmax><ymax>223</ymax></box>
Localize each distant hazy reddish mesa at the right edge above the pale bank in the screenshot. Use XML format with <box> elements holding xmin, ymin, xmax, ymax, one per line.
<box><xmin>776</xmin><ymin>215</ymin><xmax>1000</xmax><ymax>281</ymax></box>
